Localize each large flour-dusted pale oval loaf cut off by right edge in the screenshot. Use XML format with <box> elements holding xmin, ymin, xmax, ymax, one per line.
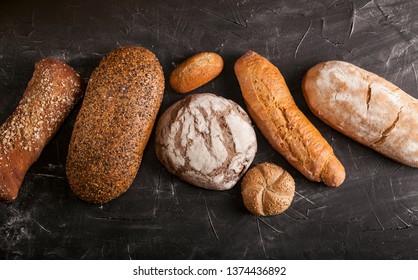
<box><xmin>302</xmin><ymin>61</ymin><xmax>418</xmax><ymax>167</ymax></box>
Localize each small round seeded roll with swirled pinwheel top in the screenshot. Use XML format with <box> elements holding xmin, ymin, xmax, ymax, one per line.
<box><xmin>241</xmin><ymin>162</ymin><xmax>295</xmax><ymax>216</ymax></box>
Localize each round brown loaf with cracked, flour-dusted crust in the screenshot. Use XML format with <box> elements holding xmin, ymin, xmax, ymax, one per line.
<box><xmin>155</xmin><ymin>93</ymin><xmax>257</xmax><ymax>190</ymax></box>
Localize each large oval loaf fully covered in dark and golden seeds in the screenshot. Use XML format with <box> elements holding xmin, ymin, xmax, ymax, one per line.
<box><xmin>66</xmin><ymin>47</ymin><xmax>164</xmax><ymax>204</ymax></box>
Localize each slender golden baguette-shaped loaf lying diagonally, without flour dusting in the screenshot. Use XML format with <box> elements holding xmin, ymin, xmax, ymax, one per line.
<box><xmin>235</xmin><ymin>51</ymin><xmax>345</xmax><ymax>187</ymax></box>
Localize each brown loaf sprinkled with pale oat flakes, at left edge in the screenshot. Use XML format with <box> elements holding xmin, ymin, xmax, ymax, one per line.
<box><xmin>0</xmin><ymin>58</ymin><xmax>83</xmax><ymax>201</ymax></box>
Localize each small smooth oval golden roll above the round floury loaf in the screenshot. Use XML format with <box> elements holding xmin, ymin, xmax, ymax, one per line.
<box><xmin>170</xmin><ymin>52</ymin><xmax>224</xmax><ymax>93</ymax></box>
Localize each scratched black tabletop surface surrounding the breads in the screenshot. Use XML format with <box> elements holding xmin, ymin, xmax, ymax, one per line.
<box><xmin>0</xmin><ymin>0</ymin><xmax>418</xmax><ymax>259</ymax></box>
